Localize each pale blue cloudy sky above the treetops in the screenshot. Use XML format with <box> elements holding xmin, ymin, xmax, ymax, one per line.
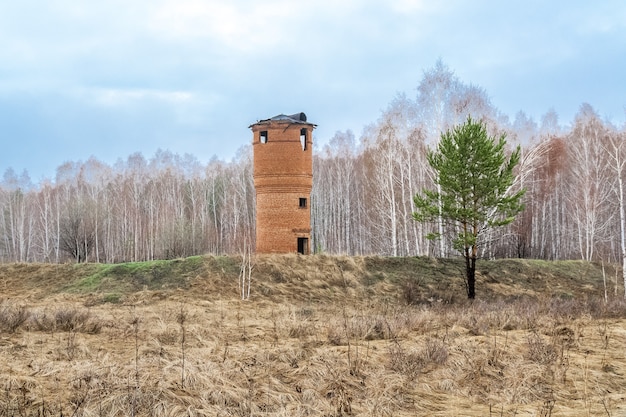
<box><xmin>0</xmin><ymin>0</ymin><xmax>626</xmax><ymax>182</ymax></box>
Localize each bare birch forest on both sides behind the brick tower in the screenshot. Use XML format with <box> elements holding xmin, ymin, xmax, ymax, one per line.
<box><xmin>0</xmin><ymin>62</ymin><xmax>626</xmax><ymax>263</ymax></box>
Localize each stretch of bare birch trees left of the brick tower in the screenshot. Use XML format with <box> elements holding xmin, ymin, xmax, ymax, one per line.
<box><xmin>0</xmin><ymin>151</ymin><xmax>254</xmax><ymax>263</ymax></box>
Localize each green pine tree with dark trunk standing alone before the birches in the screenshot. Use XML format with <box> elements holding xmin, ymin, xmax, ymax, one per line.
<box><xmin>413</xmin><ymin>117</ymin><xmax>524</xmax><ymax>299</ymax></box>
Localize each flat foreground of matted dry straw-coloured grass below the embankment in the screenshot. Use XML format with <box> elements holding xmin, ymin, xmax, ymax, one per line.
<box><xmin>0</xmin><ymin>297</ymin><xmax>626</xmax><ymax>416</ymax></box>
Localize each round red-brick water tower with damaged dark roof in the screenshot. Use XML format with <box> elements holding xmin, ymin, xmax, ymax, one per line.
<box><xmin>250</xmin><ymin>113</ymin><xmax>316</xmax><ymax>254</ymax></box>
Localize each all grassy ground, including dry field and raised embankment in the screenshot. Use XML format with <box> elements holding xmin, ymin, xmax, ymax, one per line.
<box><xmin>0</xmin><ymin>255</ymin><xmax>626</xmax><ymax>416</ymax></box>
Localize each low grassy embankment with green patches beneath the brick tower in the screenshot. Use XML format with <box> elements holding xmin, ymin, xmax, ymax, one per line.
<box><xmin>0</xmin><ymin>255</ymin><xmax>623</xmax><ymax>303</ymax></box>
